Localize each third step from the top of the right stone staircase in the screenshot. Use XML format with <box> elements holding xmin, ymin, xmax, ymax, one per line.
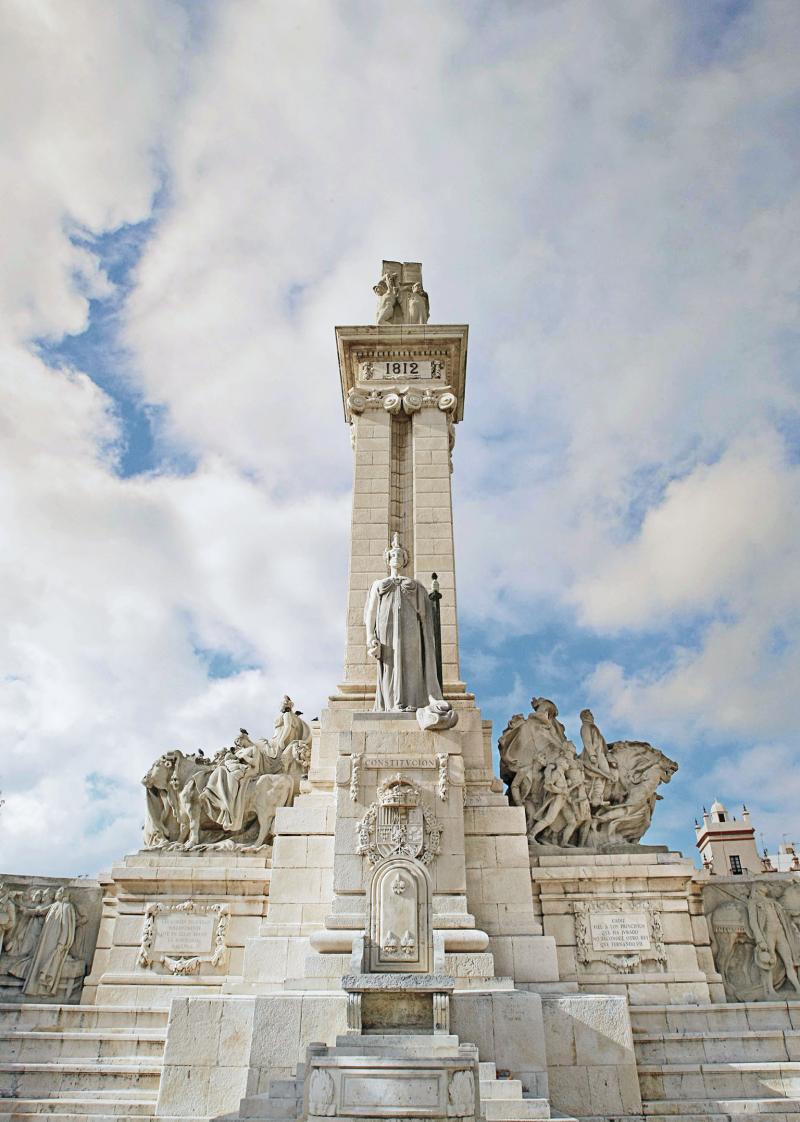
<box><xmin>638</xmin><ymin>1060</ymin><xmax>800</xmax><ymax>1102</ymax></box>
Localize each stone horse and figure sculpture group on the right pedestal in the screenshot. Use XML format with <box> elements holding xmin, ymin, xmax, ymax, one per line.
<box><xmin>498</xmin><ymin>698</ymin><xmax>678</xmax><ymax>847</ymax></box>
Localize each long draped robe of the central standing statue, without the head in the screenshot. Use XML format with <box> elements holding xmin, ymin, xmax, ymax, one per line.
<box><xmin>364</xmin><ymin>577</ymin><xmax>442</xmax><ymax>712</ymax></box>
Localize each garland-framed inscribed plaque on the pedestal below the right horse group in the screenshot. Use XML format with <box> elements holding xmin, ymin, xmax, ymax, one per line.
<box><xmin>573</xmin><ymin>899</ymin><xmax>666</xmax><ymax>974</ymax></box>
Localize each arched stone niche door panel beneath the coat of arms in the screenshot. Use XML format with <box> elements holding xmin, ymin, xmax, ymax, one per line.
<box><xmin>369</xmin><ymin>857</ymin><xmax>433</xmax><ymax>974</ymax></box>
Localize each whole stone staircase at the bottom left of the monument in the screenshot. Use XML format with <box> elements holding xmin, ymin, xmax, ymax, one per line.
<box><xmin>0</xmin><ymin>1004</ymin><xmax>168</xmax><ymax>1122</ymax></box>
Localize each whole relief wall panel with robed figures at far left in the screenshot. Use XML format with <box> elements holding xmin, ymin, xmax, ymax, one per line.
<box><xmin>0</xmin><ymin>877</ymin><xmax>100</xmax><ymax>1002</ymax></box>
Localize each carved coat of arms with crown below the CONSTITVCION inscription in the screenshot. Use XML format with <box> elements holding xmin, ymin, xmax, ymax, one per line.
<box><xmin>356</xmin><ymin>773</ymin><xmax>442</xmax><ymax>866</ymax></box>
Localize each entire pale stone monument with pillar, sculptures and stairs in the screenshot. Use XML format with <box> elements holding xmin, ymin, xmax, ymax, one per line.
<box><xmin>0</xmin><ymin>261</ymin><xmax>800</xmax><ymax>1122</ymax></box>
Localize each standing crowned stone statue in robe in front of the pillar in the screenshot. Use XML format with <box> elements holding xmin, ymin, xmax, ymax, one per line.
<box><xmin>364</xmin><ymin>533</ymin><xmax>458</xmax><ymax>729</ymax></box>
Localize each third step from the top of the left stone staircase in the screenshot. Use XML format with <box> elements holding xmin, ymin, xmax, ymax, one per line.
<box><xmin>0</xmin><ymin>1059</ymin><xmax>162</xmax><ymax>1098</ymax></box>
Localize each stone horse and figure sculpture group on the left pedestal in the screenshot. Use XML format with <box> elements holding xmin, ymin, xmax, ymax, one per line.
<box><xmin>141</xmin><ymin>696</ymin><xmax>311</xmax><ymax>849</ymax></box>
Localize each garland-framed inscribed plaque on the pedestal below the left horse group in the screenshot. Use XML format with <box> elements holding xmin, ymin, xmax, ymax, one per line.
<box><xmin>136</xmin><ymin>900</ymin><xmax>230</xmax><ymax>975</ymax></box>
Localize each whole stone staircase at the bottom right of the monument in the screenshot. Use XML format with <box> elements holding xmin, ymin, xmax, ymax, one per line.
<box><xmin>631</xmin><ymin>1001</ymin><xmax>800</xmax><ymax>1122</ymax></box>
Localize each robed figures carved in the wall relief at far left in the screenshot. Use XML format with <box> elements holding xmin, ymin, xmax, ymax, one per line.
<box><xmin>0</xmin><ymin>882</ymin><xmax>86</xmax><ymax>1001</ymax></box>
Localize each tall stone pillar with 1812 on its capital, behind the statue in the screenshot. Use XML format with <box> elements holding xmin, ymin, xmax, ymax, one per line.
<box><xmin>332</xmin><ymin>324</ymin><xmax>468</xmax><ymax>709</ymax></box>
